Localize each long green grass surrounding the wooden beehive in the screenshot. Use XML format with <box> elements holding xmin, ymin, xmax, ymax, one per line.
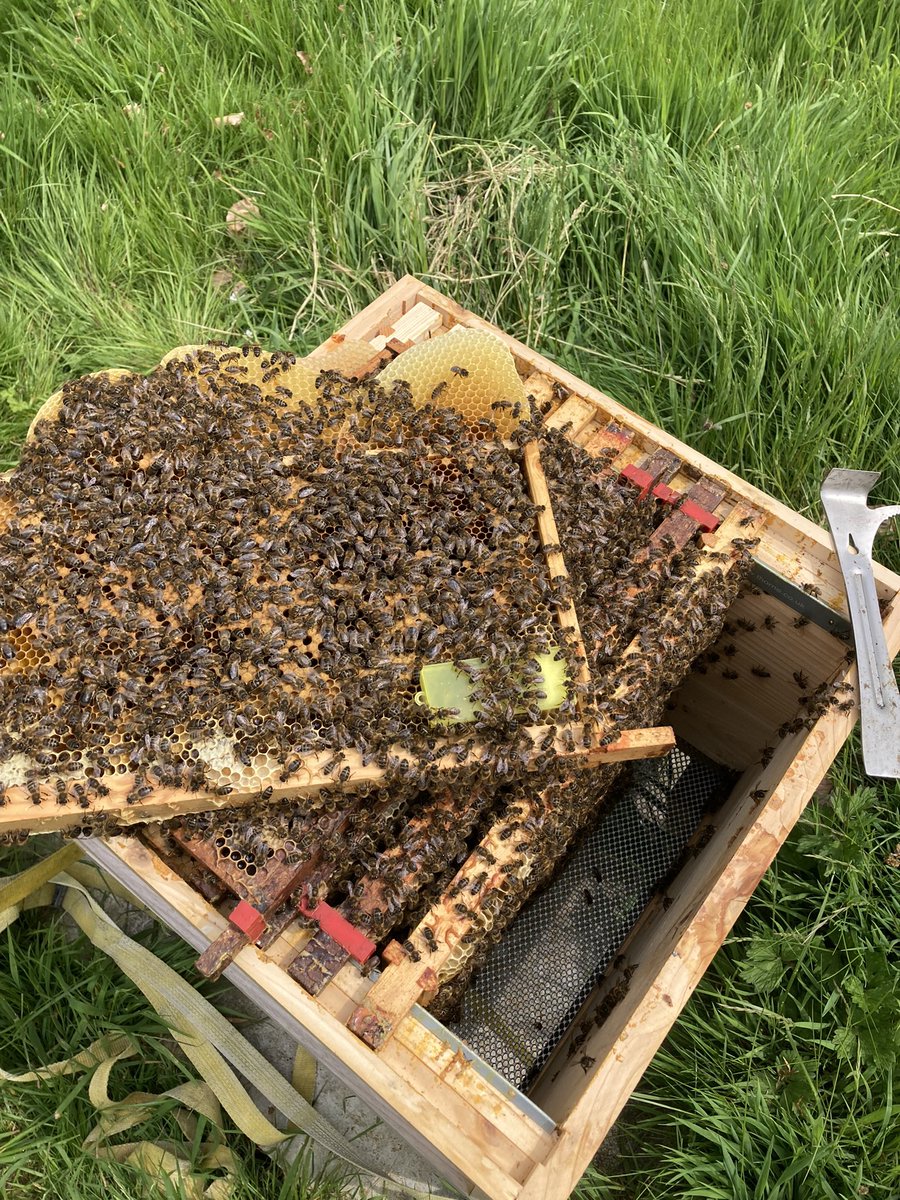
<box><xmin>0</xmin><ymin>0</ymin><xmax>900</xmax><ymax>1200</ymax></box>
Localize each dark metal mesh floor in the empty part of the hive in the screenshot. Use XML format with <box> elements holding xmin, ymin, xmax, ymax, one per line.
<box><xmin>450</xmin><ymin>746</ymin><xmax>734</xmax><ymax>1090</ymax></box>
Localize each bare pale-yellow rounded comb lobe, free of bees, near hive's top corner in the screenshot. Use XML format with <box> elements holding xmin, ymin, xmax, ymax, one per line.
<box><xmin>377</xmin><ymin>325</ymin><xmax>528</xmax><ymax>438</ymax></box>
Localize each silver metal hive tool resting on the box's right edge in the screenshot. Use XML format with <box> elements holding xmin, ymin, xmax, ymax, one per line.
<box><xmin>821</xmin><ymin>468</ymin><xmax>900</xmax><ymax>779</ymax></box>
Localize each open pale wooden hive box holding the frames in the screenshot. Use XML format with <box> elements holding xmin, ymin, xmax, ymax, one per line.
<box><xmin>72</xmin><ymin>277</ymin><xmax>900</xmax><ymax>1200</ymax></box>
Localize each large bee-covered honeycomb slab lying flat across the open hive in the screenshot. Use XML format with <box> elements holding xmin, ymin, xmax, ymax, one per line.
<box><xmin>0</xmin><ymin>345</ymin><xmax>592</xmax><ymax>835</ymax></box>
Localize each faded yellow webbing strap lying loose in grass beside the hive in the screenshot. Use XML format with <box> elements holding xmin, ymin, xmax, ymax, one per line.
<box><xmin>0</xmin><ymin>842</ymin><xmax>453</xmax><ymax>1200</ymax></box>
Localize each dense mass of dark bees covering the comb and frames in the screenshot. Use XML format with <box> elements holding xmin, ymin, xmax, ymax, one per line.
<box><xmin>0</xmin><ymin>347</ymin><xmax>742</xmax><ymax>1003</ymax></box>
